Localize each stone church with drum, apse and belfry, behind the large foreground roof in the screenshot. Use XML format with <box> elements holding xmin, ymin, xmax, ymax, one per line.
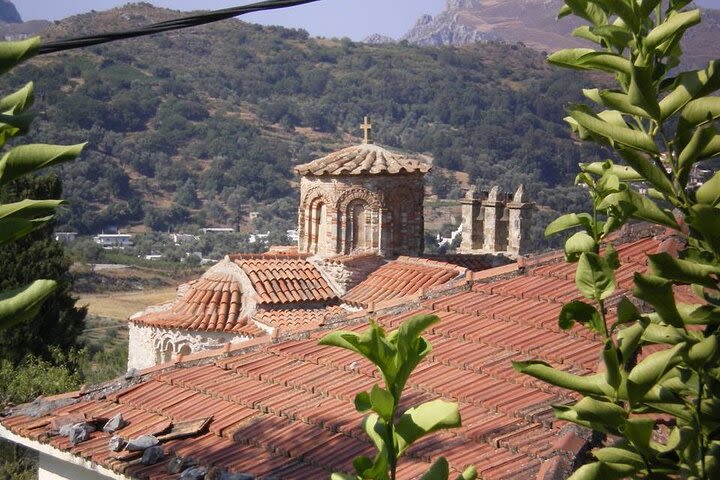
<box><xmin>122</xmin><ymin>117</ymin><xmax>531</xmax><ymax>369</ymax></box>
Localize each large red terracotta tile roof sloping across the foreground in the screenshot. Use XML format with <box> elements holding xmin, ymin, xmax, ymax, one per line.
<box><xmin>0</xmin><ymin>234</ymin><xmax>704</xmax><ymax>480</ymax></box>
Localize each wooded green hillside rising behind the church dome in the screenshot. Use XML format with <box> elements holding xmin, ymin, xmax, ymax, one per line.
<box><xmin>11</xmin><ymin>4</ymin><xmax>593</xmax><ymax>249</ymax></box>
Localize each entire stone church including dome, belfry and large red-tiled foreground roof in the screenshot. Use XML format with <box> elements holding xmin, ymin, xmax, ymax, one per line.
<box><xmin>0</xmin><ymin>122</ymin><xmax>677</xmax><ymax>480</ymax></box>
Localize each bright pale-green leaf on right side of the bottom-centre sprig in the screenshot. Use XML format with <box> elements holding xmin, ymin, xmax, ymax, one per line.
<box><xmin>395</xmin><ymin>400</ymin><xmax>460</xmax><ymax>456</ymax></box>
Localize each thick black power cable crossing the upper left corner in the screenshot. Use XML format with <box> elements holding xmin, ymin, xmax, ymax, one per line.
<box><xmin>38</xmin><ymin>0</ymin><xmax>318</xmax><ymax>55</ymax></box>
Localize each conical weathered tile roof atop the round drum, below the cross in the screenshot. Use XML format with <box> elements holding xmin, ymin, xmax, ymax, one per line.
<box><xmin>295</xmin><ymin>144</ymin><xmax>431</xmax><ymax>175</ymax></box>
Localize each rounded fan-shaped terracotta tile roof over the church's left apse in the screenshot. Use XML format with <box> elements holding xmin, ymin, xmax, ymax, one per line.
<box><xmin>131</xmin><ymin>271</ymin><xmax>262</xmax><ymax>338</ymax></box>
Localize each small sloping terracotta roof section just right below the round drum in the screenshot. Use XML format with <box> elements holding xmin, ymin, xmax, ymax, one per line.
<box><xmin>343</xmin><ymin>257</ymin><xmax>465</xmax><ymax>308</ymax></box>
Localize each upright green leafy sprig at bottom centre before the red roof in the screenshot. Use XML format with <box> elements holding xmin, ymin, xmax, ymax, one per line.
<box><xmin>320</xmin><ymin>315</ymin><xmax>477</xmax><ymax>480</ymax></box>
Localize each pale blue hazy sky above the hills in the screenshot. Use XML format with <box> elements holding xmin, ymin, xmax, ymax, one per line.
<box><xmin>14</xmin><ymin>0</ymin><xmax>720</xmax><ymax>40</ymax></box>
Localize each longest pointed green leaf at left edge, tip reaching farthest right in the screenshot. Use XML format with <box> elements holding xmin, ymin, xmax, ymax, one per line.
<box><xmin>0</xmin><ymin>143</ymin><xmax>86</xmax><ymax>185</ymax></box>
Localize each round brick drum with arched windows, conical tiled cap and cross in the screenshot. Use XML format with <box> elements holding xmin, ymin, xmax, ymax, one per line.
<box><xmin>295</xmin><ymin>118</ymin><xmax>430</xmax><ymax>256</ymax></box>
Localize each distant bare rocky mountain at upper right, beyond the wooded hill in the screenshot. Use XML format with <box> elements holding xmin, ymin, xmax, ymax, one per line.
<box><xmin>404</xmin><ymin>0</ymin><xmax>720</xmax><ymax>67</ymax></box>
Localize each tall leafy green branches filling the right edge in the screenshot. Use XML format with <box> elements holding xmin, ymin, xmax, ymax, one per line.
<box><xmin>514</xmin><ymin>0</ymin><xmax>720</xmax><ymax>480</ymax></box>
